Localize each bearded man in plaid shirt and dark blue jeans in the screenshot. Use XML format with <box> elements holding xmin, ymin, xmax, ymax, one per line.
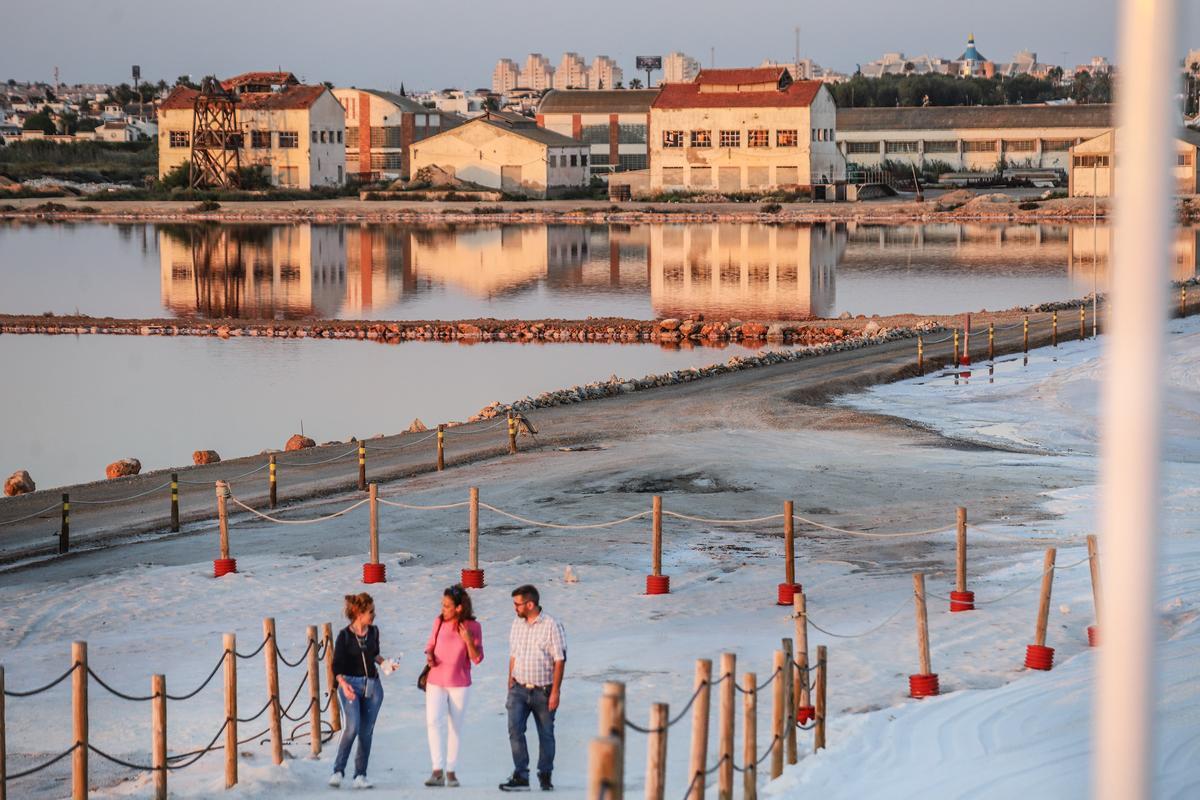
<box><xmin>500</xmin><ymin>585</ymin><xmax>566</xmax><ymax>792</ymax></box>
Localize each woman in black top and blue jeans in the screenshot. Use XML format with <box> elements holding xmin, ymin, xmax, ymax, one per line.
<box><xmin>329</xmin><ymin>591</ymin><xmax>388</xmax><ymax>789</ymax></box>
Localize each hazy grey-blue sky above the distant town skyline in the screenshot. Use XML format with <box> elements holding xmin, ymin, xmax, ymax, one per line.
<box><xmin>0</xmin><ymin>0</ymin><xmax>1200</xmax><ymax>89</ymax></box>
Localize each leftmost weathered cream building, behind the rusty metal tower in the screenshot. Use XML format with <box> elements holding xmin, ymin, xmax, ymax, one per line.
<box><xmin>158</xmin><ymin>72</ymin><xmax>346</xmax><ymax>190</ymax></box>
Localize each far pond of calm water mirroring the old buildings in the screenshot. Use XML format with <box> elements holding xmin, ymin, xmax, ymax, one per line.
<box><xmin>0</xmin><ymin>223</ymin><xmax>1198</xmax><ymax>319</ymax></box>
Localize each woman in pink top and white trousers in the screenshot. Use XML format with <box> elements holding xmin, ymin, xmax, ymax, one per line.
<box><xmin>425</xmin><ymin>584</ymin><xmax>484</xmax><ymax>786</ymax></box>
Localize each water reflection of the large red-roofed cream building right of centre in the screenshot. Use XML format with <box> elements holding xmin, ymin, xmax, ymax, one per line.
<box><xmin>648</xmin><ymin>223</ymin><xmax>846</xmax><ymax>319</ymax></box>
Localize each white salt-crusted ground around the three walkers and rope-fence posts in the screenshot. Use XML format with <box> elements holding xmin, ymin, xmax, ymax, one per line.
<box><xmin>0</xmin><ymin>321</ymin><xmax>1200</xmax><ymax>799</ymax></box>
